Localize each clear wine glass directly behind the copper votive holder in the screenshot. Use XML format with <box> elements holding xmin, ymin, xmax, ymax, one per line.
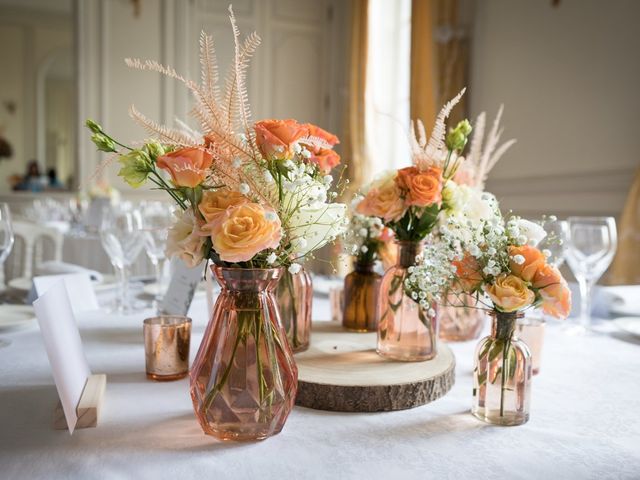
<box><xmin>141</xmin><ymin>202</ymin><xmax>171</xmax><ymax>306</ymax></box>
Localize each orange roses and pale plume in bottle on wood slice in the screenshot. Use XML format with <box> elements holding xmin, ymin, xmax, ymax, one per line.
<box><xmin>356</xmin><ymin>90</ymin><xmax>471</xmax><ymax>241</ymax></box>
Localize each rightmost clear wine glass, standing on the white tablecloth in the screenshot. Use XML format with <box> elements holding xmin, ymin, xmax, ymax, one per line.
<box><xmin>567</xmin><ymin>217</ymin><xmax>617</xmax><ymax>333</ymax></box>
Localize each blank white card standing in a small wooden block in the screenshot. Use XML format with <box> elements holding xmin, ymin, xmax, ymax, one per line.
<box><xmin>33</xmin><ymin>280</ymin><xmax>91</xmax><ymax>433</ymax></box>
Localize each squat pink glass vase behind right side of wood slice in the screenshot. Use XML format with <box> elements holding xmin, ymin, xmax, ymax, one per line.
<box><xmin>438</xmin><ymin>292</ymin><xmax>486</xmax><ymax>342</ymax></box>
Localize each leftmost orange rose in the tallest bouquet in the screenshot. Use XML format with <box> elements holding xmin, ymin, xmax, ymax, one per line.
<box><xmin>157</xmin><ymin>147</ymin><xmax>213</xmax><ymax>188</ymax></box>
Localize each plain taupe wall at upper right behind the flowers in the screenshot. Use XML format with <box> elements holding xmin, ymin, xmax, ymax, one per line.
<box><xmin>470</xmin><ymin>0</ymin><xmax>640</xmax><ymax>216</ymax></box>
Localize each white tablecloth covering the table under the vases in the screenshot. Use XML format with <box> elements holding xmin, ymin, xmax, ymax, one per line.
<box><xmin>0</xmin><ymin>290</ymin><xmax>640</xmax><ymax>479</ymax></box>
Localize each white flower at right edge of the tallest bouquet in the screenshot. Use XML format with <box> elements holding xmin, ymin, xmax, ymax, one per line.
<box><xmin>289</xmin><ymin>203</ymin><xmax>347</xmax><ymax>256</ymax></box>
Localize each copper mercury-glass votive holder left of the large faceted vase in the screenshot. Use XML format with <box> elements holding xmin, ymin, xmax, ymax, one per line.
<box><xmin>142</xmin><ymin>315</ymin><xmax>191</xmax><ymax>382</ymax></box>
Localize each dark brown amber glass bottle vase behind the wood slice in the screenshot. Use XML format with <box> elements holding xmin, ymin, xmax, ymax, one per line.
<box><xmin>342</xmin><ymin>262</ymin><xmax>382</xmax><ymax>332</ymax></box>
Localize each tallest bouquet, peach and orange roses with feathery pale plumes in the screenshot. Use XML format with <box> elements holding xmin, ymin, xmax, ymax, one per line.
<box><xmin>87</xmin><ymin>11</ymin><xmax>346</xmax><ymax>273</ymax></box>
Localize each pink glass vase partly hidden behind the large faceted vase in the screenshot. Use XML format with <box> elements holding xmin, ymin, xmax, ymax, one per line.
<box><xmin>277</xmin><ymin>268</ymin><xmax>313</xmax><ymax>352</ymax></box>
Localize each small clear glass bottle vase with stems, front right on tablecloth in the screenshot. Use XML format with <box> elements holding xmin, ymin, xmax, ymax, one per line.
<box><xmin>471</xmin><ymin>312</ymin><xmax>531</xmax><ymax>425</ymax></box>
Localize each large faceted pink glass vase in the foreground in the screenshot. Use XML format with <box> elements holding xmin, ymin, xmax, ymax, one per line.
<box><xmin>190</xmin><ymin>267</ymin><xmax>298</xmax><ymax>440</ymax></box>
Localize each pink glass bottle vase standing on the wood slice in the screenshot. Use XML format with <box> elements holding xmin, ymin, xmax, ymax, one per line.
<box><xmin>377</xmin><ymin>241</ymin><xmax>438</xmax><ymax>362</ymax></box>
